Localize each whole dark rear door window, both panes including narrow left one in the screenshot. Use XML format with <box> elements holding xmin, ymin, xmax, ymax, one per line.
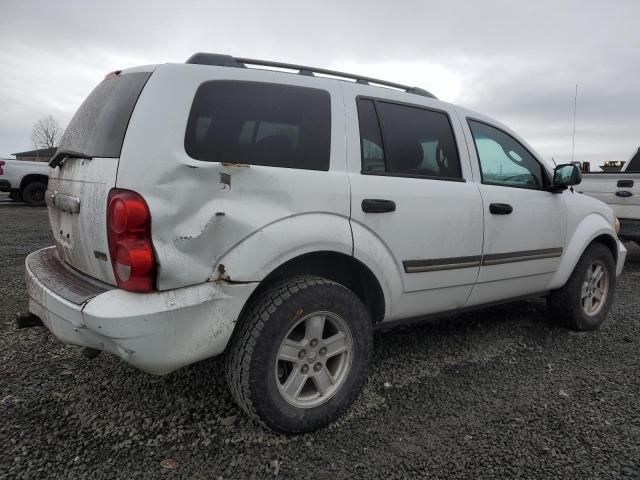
<box><xmin>358</xmin><ymin>99</ymin><xmax>462</xmax><ymax>179</ymax></box>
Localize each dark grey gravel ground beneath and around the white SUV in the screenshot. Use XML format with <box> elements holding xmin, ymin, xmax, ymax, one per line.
<box><xmin>0</xmin><ymin>202</ymin><xmax>640</xmax><ymax>480</ymax></box>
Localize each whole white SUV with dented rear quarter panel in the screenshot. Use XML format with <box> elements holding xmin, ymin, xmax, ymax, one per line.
<box><xmin>23</xmin><ymin>54</ymin><xmax>626</xmax><ymax>432</ymax></box>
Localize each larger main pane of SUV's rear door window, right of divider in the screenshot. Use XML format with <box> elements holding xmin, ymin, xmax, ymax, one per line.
<box><xmin>376</xmin><ymin>101</ymin><xmax>462</xmax><ymax>178</ymax></box>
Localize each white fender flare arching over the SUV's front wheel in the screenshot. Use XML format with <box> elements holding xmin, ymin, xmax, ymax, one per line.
<box><xmin>549</xmin><ymin>213</ymin><xmax>618</xmax><ymax>290</ymax></box>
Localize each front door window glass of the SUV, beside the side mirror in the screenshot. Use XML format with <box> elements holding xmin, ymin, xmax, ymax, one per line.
<box><xmin>469</xmin><ymin>120</ymin><xmax>545</xmax><ymax>188</ymax></box>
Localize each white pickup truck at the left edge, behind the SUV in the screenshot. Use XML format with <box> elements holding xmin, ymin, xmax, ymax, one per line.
<box><xmin>0</xmin><ymin>160</ymin><xmax>49</xmax><ymax>206</ymax></box>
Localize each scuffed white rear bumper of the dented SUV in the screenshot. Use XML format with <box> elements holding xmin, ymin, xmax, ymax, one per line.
<box><xmin>26</xmin><ymin>247</ymin><xmax>257</xmax><ymax>375</ymax></box>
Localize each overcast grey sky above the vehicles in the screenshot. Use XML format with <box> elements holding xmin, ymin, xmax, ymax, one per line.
<box><xmin>0</xmin><ymin>0</ymin><xmax>640</xmax><ymax>163</ymax></box>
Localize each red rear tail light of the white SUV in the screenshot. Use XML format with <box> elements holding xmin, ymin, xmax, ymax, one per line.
<box><xmin>107</xmin><ymin>189</ymin><xmax>156</xmax><ymax>292</ymax></box>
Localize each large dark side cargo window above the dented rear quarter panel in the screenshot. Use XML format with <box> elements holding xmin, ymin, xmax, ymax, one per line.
<box><xmin>184</xmin><ymin>80</ymin><xmax>331</xmax><ymax>170</ymax></box>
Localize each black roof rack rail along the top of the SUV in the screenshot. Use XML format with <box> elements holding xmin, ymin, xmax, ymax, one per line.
<box><xmin>186</xmin><ymin>53</ymin><xmax>437</xmax><ymax>99</ymax></box>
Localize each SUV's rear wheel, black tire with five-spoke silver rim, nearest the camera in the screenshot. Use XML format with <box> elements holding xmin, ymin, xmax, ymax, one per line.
<box><xmin>226</xmin><ymin>277</ymin><xmax>372</xmax><ymax>433</ymax></box>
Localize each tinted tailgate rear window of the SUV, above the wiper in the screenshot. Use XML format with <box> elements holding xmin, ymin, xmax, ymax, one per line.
<box><xmin>59</xmin><ymin>72</ymin><xmax>151</xmax><ymax>158</ymax></box>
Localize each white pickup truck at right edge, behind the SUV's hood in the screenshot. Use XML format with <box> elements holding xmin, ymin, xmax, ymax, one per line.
<box><xmin>576</xmin><ymin>149</ymin><xmax>640</xmax><ymax>244</ymax></box>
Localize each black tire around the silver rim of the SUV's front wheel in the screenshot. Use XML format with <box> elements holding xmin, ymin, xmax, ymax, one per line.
<box><xmin>547</xmin><ymin>243</ymin><xmax>616</xmax><ymax>332</ymax></box>
